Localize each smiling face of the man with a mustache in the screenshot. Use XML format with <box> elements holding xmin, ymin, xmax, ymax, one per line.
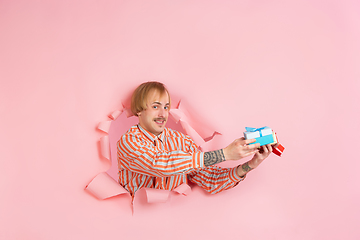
<box><xmin>138</xmin><ymin>90</ymin><xmax>170</xmax><ymax>135</ymax></box>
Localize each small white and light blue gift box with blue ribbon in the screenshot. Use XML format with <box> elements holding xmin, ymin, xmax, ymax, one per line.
<box><xmin>244</xmin><ymin>127</ymin><xmax>277</xmax><ymax>146</ymax></box>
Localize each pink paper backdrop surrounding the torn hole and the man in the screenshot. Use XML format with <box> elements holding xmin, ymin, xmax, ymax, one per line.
<box><xmin>0</xmin><ymin>0</ymin><xmax>360</xmax><ymax>240</ymax></box>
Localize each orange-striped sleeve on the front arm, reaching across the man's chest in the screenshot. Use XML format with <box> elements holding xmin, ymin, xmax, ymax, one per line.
<box><xmin>117</xmin><ymin>134</ymin><xmax>204</xmax><ymax>177</ymax></box>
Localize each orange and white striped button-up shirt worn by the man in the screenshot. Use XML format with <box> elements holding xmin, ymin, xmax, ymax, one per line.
<box><xmin>117</xmin><ymin>125</ymin><xmax>245</xmax><ymax>197</ymax></box>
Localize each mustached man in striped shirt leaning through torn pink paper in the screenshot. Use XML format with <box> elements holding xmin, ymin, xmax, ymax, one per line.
<box><xmin>117</xmin><ymin>82</ymin><xmax>276</xmax><ymax>198</ymax></box>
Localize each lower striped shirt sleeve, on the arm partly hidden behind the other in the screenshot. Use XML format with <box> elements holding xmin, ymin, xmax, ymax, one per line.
<box><xmin>188</xmin><ymin>166</ymin><xmax>245</xmax><ymax>194</ymax></box>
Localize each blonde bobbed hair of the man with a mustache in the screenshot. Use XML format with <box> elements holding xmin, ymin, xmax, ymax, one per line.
<box><xmin>131</xmin><ymin>81</ymin><xmax>171</xmax><ymax>116</ymax></box>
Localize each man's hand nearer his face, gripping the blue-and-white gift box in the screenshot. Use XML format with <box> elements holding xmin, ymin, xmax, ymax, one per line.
<box><xmin>223</xmin><ymin>137</ymin><xmax>260</xmax><ymax>160</ymax></box>
